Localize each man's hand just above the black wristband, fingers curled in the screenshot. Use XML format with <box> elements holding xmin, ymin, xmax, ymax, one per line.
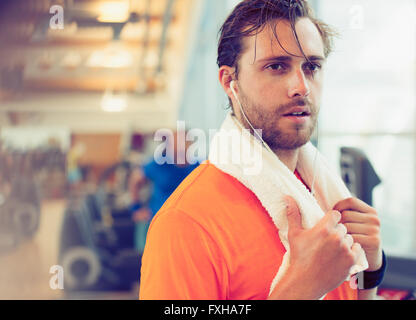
<box><xmin>333</xmin><ymin>198</ymin><xmax>383</xmax><ymax>271</ymax></box>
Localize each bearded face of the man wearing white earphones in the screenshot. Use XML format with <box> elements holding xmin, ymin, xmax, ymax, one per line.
<box><xmin>233</xmin><ymin>18</ymin><xmax>325</xmax><ymax>151</ymax></box>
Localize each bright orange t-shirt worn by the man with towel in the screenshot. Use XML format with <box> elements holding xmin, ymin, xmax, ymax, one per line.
<box><xmin>139</xmin><ymin>161</ymin><xmax>357</xmax><ymax>300</ymax></box>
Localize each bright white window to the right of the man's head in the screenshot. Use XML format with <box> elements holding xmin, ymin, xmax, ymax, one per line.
<box><xmin>314</xmin><ymin>0</ymin><xmax>416</xmax><ymax>256</ymax></box>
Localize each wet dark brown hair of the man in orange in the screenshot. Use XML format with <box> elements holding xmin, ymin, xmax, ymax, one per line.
<box><xmin>217</xmin><ymin>0</ymin><xmax>336</xmax><ymax>77</ymax></box>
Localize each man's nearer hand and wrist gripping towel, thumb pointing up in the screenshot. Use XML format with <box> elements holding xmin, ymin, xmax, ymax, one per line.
<box><xmin>269</xmin><ymin>196</ymin><xmax>361</xmax><ymax>300</ymax></box>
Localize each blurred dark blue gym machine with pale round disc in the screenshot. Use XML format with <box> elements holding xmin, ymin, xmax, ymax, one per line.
<box><xmin>59</xmin><ymin>162</ymin><xmax>141</xmax><ymax>293</ymax></box>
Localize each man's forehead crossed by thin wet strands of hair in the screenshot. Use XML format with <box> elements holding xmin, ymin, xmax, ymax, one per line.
<box><xmin>243</xmin><ymin>18</ymin><xmax>324</xmax><ymax>63</ymax></box>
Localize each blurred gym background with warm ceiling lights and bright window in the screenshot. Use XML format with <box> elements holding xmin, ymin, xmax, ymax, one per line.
<box><xmin>0</xmin><ymin>0</ymin><xmax>416</xmax><ymax>300</ymax></box>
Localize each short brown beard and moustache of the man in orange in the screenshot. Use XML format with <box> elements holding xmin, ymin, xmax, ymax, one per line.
<box><xmin>236</xmin><ymin>90</ymin><xmax>318</xmax><ymax>151</ymax></box>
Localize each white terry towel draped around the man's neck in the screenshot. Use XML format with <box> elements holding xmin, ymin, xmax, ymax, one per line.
<box><xmin>209</xmin><ymin>113</ymin><xmax>368</xmax><ymax>293</ymax></box>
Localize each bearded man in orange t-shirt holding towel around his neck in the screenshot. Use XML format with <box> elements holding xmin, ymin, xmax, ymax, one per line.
<box><xmin>140</xmin><ymin>0</ymin><xmax>384</xmax><ymax>300</ymax></box>
